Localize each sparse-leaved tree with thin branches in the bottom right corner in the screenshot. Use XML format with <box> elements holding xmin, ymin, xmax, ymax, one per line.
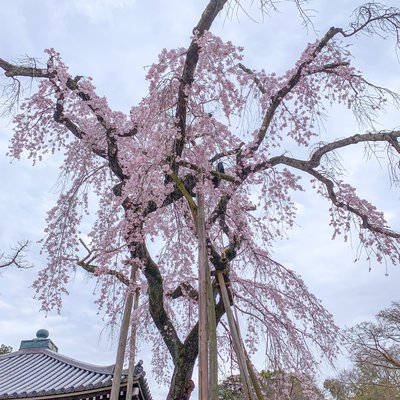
<box><xmin>324</xmin><ymin>302</ymin><xmax>400</xmax><ymax>400</ymax></box>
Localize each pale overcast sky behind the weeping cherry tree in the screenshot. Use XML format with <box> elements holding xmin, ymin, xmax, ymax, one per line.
<box><xmin>0</xmin><ymin>0</ymin><xmax>400</xmax><ymax>399</ymax></box>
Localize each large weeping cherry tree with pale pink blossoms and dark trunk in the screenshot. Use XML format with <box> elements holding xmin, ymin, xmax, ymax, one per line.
<box><xmin>0</xmin><ymin>0</ymin><xmax>400</xmax><ymax>400</ymax></box>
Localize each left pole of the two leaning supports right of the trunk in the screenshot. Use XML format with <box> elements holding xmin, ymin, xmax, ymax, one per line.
<box><xmin>217</xmin><ymin>271</ymin><xmax>254</xmax><ymax>400</ymax></box>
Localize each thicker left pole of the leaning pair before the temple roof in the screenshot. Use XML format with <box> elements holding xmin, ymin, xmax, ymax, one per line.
<box><xmin>110</xmin><ymin>265</ymin><xmax>137</xmax><ymax>400</ymax></box>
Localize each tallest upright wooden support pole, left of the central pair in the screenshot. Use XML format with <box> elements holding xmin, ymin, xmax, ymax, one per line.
<box><xmin>197</xmin><ymin>190</ymin><xmax>208</xmax><ymax>399</ymax></box>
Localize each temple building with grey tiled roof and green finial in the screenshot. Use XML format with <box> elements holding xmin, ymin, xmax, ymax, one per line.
<box><xmin>0</xmin><ymin>329</ymin><xmax>152</xmax><ymax>400</ymax></box>
